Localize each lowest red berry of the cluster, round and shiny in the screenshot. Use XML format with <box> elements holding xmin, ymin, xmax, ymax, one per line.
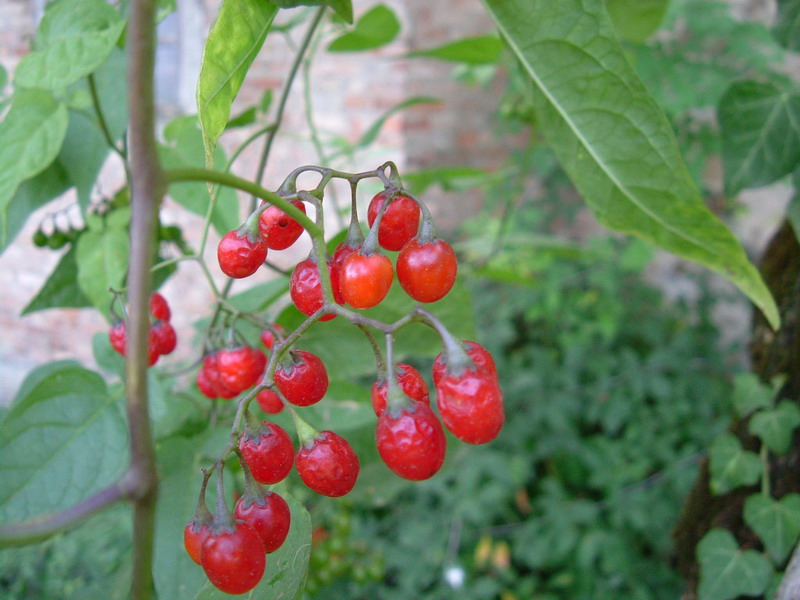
<box><xmin>200</xmin><ymin>521</ymin><xmax>267</xmax><ymax>594</ymax></box>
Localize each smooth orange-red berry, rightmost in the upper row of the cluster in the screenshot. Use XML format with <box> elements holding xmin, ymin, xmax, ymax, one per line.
<box><xmin>397</xmin><ymin>238</ymin><xmax>458</xmax><ymax>302</ymax></box>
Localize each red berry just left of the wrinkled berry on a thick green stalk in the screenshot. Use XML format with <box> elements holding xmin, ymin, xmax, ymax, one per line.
<box><xmin>239</xmin><ymin>421</ymin><xmax>294</xmax><ymax>485</ymax></box>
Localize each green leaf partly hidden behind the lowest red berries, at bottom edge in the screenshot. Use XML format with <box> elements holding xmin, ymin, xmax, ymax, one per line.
<box><xmin>195</xmin><ymin>491</ymin><xmax>311</xmax><ymax>600</ymax></box>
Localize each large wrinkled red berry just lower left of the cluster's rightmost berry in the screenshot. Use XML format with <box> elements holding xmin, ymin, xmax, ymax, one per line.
<box><xmin>375</xmin><ymin>402</ymin><xmax>447</xmax><ymax>481</ymax></box>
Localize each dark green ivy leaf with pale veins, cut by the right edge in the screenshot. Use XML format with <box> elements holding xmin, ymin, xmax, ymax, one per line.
<box><xmin>719</xmin><ymin>81</ymin><xmax>800</xmax><ymax>195</ymax></box>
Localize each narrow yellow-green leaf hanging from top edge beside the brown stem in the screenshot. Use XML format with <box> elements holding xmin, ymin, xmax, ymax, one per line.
<box><xmin>197</xmin><ymin>0</ymin><xmax>278</xmax><ymax>166</ymax></box>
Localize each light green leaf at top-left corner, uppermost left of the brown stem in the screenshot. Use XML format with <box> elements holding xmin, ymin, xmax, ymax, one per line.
<box><xmin>14</xmin><ymin>0</ymin><xmax>125</xmax><ymax>90</ymax></box>
